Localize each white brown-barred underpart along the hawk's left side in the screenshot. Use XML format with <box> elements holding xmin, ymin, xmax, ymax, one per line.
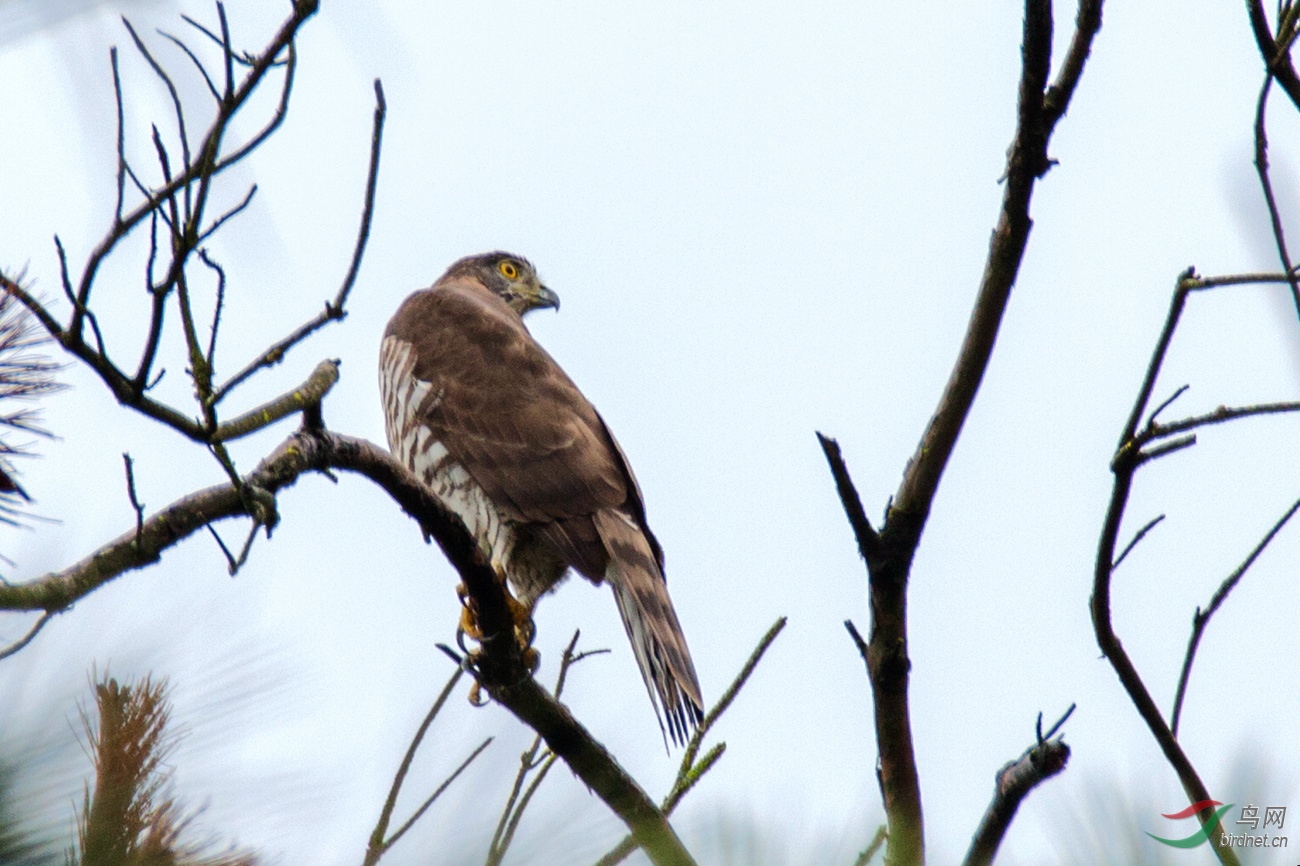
<box><xmin>380</xmin><ymin>337</ymin><xmax>515</xmax><ymax>575</ymax></box>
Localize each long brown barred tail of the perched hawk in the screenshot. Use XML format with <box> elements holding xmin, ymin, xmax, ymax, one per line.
<box><xmin>594</xmin><ymin>510</ymin><xmax>703</xmax><ymax>745</ymax></box>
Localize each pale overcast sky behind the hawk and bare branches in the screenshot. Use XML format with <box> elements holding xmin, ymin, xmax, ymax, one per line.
<box><xmin>0</xmin><ymin>0</ymin><xmax>1300</xmax><ymax>866</ymax></box>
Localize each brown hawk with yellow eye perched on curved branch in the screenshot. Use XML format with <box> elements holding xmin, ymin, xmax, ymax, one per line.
<box><xmin>380</xmin><ymin>252</ymin><xmax>703</xmax><ymax>742</ymax></box>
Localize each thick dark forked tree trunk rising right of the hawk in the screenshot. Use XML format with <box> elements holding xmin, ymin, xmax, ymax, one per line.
<box><xmin>819</xmin><ymin>0</ymin><xmax>1102</xmax><ymax>866</ymax></box>
